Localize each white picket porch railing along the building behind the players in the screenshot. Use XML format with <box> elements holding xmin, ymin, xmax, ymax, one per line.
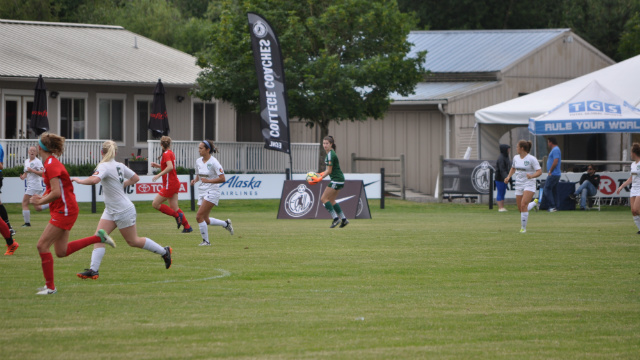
<box><xmin>0</xmin><ymin>139</ymin><xmax>320</xmax><ymax>174</ymax></box>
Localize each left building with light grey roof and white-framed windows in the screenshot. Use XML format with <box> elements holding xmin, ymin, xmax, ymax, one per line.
<box><xmin>0</xmin><ymin>19</ymin><xmax>235</xmax><ymax>162</ymax></box>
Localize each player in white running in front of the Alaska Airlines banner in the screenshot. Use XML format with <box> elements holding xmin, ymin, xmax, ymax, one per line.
<box><xmin>191</xmin><ymin>140</ymin><xmax>233</xmax><ymax>246</ymax></box>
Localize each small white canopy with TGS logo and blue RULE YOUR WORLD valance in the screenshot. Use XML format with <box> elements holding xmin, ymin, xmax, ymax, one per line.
<box><xmin>529</xmin><ymin>80</ymin><xmax>640</xmax><ymax>135</ymax></box>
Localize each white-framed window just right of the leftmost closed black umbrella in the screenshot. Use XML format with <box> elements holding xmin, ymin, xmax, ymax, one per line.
<box><xmin>58</xmin><ymin>92</ymin><xmax>89</xmax><ymax>139</ymax></box>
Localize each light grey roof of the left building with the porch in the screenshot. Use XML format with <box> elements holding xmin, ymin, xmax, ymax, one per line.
<box><xmin>0</xmin><ymin>19</ymin><xmax>200</xmax><ymax>86</ymax></box>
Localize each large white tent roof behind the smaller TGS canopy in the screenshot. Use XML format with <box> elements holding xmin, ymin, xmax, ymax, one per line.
<box><xmin>475</xmin><ymin>55</ymin><xmax>640</xmax><ymax>159</ymax></box>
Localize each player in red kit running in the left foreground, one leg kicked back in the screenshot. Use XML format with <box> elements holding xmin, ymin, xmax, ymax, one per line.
<box><xmin>30</xmin><ymin>133</ymin><xmax>116</xmax><ymax>295</ymax></box>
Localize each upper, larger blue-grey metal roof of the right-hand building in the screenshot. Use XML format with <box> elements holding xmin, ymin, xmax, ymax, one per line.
<box><xmin>408</xmin><ymin>29</ymin><xmax>571</xmax><ymax>73</ymax></box>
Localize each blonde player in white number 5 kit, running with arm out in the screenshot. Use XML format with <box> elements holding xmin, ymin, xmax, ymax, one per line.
<box><xmin>71</xmin><ymin>140</ymin><xmax>172</xmax><ymax>280</ymax></box>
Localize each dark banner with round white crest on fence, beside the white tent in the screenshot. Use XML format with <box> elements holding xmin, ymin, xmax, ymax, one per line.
<box><xmin>442</xmin><ymin>159</ymin><xmax>495</xmax><ymax>194</ymax></box>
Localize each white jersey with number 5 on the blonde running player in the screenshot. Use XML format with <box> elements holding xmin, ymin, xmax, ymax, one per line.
<box><xmin>93</xmin><ymin>160</ymin><xmax>135</xmax><ymax>215</ymax></box>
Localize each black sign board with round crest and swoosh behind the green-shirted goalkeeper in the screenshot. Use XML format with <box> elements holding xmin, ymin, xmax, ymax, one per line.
<box><xmin>278</xmin><ymin>180</ymin><xmax>371</xmax><ymax>219</ymax></box>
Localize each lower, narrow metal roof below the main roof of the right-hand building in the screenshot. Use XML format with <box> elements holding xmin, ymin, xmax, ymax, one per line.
<box><xmin>391</xmin><ymin>81</ymin><xmax>498</xmax><ymax>104</ymax></box>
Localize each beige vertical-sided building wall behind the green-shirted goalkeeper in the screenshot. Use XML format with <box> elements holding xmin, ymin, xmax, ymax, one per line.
<box><xmin>291</xmin><ymin>106</ymin><xmax>445</xmax><ymax>194</ymax></box>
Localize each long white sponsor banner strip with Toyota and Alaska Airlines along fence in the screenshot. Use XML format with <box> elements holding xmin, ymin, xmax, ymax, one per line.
<box><xmin>1</xmin><ymin>174</ymin><xmax>380</xmax><ymax>203</ymax></box>
